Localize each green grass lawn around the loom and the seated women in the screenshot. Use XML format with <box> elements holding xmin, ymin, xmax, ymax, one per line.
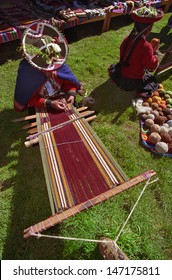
<box><xmin>0</xmin><ymin>13</ymin><xmax>172</xmax><ymax>260</ymax></box>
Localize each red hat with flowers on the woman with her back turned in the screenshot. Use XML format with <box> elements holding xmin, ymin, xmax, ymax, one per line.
<box><xmin>131</xmin><ymin>7</ymin><xmax>164</xmax><ymax>24</ymax></box>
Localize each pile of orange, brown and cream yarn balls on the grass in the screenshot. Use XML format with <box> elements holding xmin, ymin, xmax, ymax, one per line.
<box><xmin>140</xmin><ymin>88</ymin><xmax>172</xmax><ymax>157</ymax></box>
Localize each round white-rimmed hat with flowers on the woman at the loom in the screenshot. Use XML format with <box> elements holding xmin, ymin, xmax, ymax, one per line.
<box><xmin>22</xmin><ymin>22</ymin><xmax>68</xmax><ymax>71</ymax></box>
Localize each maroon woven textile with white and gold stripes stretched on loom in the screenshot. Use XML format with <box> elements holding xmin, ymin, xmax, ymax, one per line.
<box><xmin>37</xmin><ymin>105</ymin><xmax>127</xmax><ymax>213</ymax></box>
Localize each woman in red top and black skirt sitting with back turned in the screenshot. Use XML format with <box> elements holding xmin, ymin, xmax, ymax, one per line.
<box><xmin>108</xmin><ymin>7</ymin><xmax>163</xmax><ymax>96</ymax></box>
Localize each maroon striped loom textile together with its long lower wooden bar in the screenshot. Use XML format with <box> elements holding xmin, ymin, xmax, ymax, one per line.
<box><xmin>24</xmin><ymin>108</ymin><xmax>156</xmax><ymax>238</ymax></box>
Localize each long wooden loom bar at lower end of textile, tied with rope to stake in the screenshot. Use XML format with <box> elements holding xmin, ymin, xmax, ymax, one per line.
<box><xmin>24</xmin><ymin>170</ymin><xmax>156</xmax><ymax>238</ymax></box>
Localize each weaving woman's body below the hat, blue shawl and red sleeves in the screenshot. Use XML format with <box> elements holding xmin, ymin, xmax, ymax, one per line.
<box><xmin>14</xmin><ymin>59</ymin><xmax>81</xmax><ymax>112</ymax></box>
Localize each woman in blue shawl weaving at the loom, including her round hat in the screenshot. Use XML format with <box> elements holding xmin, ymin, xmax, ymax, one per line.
<box><xmin>14</xmin><ymin>23</ymin><xmax>81</xmax><ymax>111</ymax></box>
